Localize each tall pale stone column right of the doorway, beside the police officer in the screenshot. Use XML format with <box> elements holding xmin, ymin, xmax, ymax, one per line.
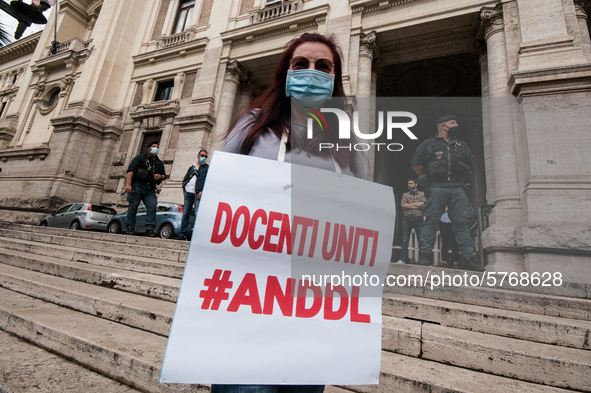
<box><xmin>480</xmin><ymin>4</ymin><xmax>524</xmax><ymax>272</ymax></box>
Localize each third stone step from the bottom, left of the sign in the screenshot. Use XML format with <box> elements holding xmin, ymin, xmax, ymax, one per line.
<box><xmin>0</xmin><ymin>249</ymin><xmax>181</xmax><ymax>302</ymax></box>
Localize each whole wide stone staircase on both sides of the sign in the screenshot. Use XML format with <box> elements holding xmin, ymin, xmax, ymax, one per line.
<box><xmin>0</xmin><ymin>222</ymin><xmax>591</xmax><ymax>393</ymax></box>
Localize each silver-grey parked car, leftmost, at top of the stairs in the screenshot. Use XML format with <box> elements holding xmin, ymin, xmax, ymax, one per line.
<box><xmin>40</xmin><ymin>202</ymin><xmax>117</xmax><ymax>231</ymax></box>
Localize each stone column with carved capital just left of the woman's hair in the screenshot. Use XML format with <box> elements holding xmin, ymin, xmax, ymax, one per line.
<box><xmin>210</xmin><ymin>60</ymin><xmax>246</xmax><ymax>154</ymax></box>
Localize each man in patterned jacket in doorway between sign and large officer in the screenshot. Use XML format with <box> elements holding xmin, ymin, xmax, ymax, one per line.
<box><xmin>396</xmin><ymin>179</ymin><xmax>425</xmax><ymax>264</ymax></box>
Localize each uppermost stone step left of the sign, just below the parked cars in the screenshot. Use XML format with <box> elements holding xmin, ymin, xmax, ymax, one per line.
<box><xmin>0</xmin><ymin>225</ymin><xmax>188</xmax><ymax>262</ymax></box>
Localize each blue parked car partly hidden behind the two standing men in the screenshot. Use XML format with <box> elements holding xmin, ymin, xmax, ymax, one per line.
<box><xmin>107</xmin><ymin>202</ymin><xmax>195</xmax><ymax>239</ymax></box>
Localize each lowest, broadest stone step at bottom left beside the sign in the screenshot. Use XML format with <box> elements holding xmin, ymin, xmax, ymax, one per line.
<box><xmin>0</xmin><ymin>288</ymin><xmax>207</xmax><ymax>393</ymax></box>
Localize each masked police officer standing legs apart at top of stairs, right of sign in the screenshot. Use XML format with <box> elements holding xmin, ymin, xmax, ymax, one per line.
<box><xmin>411</xmin><ymin>115</ymin><xmax>482</xmax><ymax>271</ymax></box>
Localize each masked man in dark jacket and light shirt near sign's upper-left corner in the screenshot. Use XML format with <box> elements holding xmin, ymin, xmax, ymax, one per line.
<box><xmin>176</xmin><ymin>150</ymin><xmax>209</xmax><ymax>240</ymax></box>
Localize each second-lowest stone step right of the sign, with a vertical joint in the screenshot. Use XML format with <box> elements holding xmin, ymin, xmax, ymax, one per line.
<box><xmin>382</xmin><ymin>316</ymin><xmax>591</xmax><ymax>392</ymax></box>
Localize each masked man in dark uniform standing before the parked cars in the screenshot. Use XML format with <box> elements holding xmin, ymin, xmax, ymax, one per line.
<box><xmin>125</xmin><ymin>141</ymin><xmax>166</xmax><ymax>237</ymax></box>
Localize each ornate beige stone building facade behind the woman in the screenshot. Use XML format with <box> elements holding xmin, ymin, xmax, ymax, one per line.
<box><xmin>0</xmin><ymin>0</ymin><xmax>591</xmax><ymax>282</ymax></box>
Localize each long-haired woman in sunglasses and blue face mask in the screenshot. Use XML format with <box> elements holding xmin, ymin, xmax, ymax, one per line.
<box><xmin>223</xmin><ymin>33</ymin><xmax>366</xmax><ymax>178</ymax></box>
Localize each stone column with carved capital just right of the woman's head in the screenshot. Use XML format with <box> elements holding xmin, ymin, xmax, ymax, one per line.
<box><xmin>355</xmin><ymin>31</ymin><xmax>379</xmax><ymax>180</ymax></box>
